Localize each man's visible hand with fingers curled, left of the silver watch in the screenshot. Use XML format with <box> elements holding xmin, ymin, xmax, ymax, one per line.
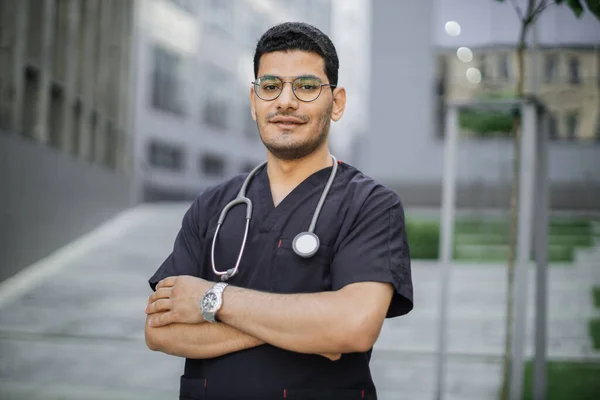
<box><xmin>145</xmin><ymin>276</ymin><xmax>214</xmax><ymax>328</ymax></box>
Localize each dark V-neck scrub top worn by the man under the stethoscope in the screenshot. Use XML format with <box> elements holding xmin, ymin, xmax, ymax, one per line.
<box><xmin>149</xmin><ymin>162</ymin><xmax>413</xmax><ymax>400</ymax></box>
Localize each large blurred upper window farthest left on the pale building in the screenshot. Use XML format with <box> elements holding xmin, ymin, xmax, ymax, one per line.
<box><xmin>152</xmin><ymin>46</ymin><xmax>184</xmax><ymax>114</ymax></box>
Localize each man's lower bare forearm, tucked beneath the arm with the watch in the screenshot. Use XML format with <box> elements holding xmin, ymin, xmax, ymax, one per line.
<box><xmin>145</xmin><ymin>314</ymin><xmax>264</xmax><ymax>359</ymax></box>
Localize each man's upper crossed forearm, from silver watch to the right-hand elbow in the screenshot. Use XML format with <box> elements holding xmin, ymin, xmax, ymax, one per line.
<box><xmin>217</xmin><ymin>286</ymin><xmax>361</xmax><ymax>354</ymax></box>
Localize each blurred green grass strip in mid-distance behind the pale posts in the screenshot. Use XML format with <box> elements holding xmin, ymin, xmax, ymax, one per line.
<box><xmin>406</xmin><ymin>217</ymin><xmax>595</xmax><ymax>262</ymax></box>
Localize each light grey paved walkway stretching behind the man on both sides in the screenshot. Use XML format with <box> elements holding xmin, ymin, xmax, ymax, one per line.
<box><xmin>0</xmin><ymin>205</ymin><xmax>600</xmax><ymax>400</ymax></box>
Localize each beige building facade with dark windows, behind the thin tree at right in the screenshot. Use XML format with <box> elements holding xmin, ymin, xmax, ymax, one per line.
<box><xmin>440</xmin><ymin>44</ymin><xmax>600</xmax><ymax>141</ymax></box>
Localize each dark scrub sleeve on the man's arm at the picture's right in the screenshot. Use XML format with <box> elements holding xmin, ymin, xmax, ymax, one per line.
<box><xmin>331</xmin><ymin>190</ymin><xmax>413</xmax><ymax>318</ymax></box>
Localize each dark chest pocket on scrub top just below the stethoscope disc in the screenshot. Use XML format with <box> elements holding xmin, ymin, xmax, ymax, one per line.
<box><xmin>273</xmin><ymin>238</ymin><xmax>332</xmax><ymax>293</ymax></box>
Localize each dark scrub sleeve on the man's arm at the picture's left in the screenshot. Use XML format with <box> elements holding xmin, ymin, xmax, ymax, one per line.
<box><xmin>148</xmin><ymin>199</ymin><xmax>203</xmax><ymax>290</ymax></box>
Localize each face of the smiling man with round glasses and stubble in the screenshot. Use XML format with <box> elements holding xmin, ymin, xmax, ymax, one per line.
<box><xmin>250</xmin><ymin>51</ymin><xmax>345</xmax><ymax>160</ymax></box>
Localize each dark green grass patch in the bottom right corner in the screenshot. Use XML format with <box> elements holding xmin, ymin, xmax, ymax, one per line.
<box><xmin>523</xmin><ymin>361</ymin><xmax>600</xmax><ymax>400</ymax></box>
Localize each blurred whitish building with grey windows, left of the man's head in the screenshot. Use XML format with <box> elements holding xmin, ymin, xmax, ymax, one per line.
<box><xmin>135</xmin><ymin>0</ymin><xmax>331</xmax><ymax>201</ymax></box>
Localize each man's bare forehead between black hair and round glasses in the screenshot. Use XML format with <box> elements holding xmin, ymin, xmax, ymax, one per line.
<box><xmin>258</xmin><ymin>50</ymin><xmax>327</xmax><ymax>80</ymax></box>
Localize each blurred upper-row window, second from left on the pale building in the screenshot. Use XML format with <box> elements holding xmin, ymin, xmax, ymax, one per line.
<box><xmin>202</xmin><ymin>66</ymin><xmax>233</xmax><ymax>129</ymax></box>
